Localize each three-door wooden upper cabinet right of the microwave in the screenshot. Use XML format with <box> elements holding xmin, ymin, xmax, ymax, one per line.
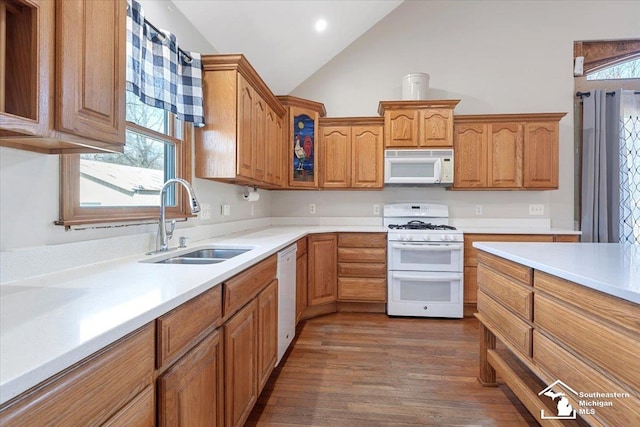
<box><xmin>453</xmin><ymin>113</ymin><xmax>565</xmax><ymax>190</ymax></box>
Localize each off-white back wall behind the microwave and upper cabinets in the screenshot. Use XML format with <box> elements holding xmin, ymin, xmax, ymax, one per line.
<box><xmin>278</xmin><ymin>0</ymin><xmax>640</xmax><ymax>228</ymax></box>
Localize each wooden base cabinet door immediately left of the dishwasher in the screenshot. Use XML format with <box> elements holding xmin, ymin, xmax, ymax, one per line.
<box><xmin>258</xmin><ymin>280</ymin><xmax>278</xmax><ymax>394</ymax></box>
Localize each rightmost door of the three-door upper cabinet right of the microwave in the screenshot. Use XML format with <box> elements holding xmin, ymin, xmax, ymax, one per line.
<box><xmin>523</xmin><ymin>122</ymin><xmax>558</xmax><ymax>189</ymax></box>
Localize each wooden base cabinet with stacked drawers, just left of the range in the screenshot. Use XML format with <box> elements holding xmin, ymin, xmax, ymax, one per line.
<box><xmin>338</xmin><ymin>233</ymin><xmax>387</xmax><ymax>303</ymax></box>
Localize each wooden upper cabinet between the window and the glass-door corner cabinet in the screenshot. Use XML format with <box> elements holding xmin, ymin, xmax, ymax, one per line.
<box><xmin>195</xmin><ymin>55</ymin><xmax>285</xmax><ymax>188</ymax></box>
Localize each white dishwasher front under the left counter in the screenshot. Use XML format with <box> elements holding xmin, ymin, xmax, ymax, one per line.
<box><xmin>276</xmin><ymin>245</ymin><xmax>297</xmax><ymax>366</ymax></box>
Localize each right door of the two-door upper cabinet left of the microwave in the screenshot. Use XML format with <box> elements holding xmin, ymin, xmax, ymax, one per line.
<box><xmin>351</xmin><ymin>126</ymin><xmax>384</xmax><ymax>188</ymax></box>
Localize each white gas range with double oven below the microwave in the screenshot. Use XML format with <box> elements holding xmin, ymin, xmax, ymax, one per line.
<box><xmin>383</xmin><ymin>203</ymin><xmax>464</xmax><ymax>318</ymax></box>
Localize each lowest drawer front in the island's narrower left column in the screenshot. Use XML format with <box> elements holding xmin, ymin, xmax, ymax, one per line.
<box><xmin>478</xmin><ymin>290</ymin><xmax>532</xmax><ymax>356</ymax></box>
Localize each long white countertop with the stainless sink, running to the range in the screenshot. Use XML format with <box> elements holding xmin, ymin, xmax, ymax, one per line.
<box><xmin>0</xmin><ymin>226</ymin><xmax>386</xmax><ymax>404</ymax></box>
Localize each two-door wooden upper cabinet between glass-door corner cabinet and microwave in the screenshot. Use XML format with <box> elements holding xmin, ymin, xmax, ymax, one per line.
<box><xmin>320</xmin><ymin>117</ymin><xmax>384</xmax><ymax>189</ymax></box>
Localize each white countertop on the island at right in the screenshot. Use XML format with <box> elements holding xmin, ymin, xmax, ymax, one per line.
<box><xmin>473</xmin><ymin>242</ymin><xmax>640</xmax><ymax>304</ymax></box>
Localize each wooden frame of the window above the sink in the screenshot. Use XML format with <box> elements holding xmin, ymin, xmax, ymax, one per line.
<box><xmin>55</xmin><ymin>115</ymin><xmax>195</xmax><ymax>228</ymax></box>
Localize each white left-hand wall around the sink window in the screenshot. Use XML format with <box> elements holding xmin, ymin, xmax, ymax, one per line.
<box><xmin>0</xmin><ymin>0</ymin><xmax>270</xmax><ymax>251</ymax></box>
